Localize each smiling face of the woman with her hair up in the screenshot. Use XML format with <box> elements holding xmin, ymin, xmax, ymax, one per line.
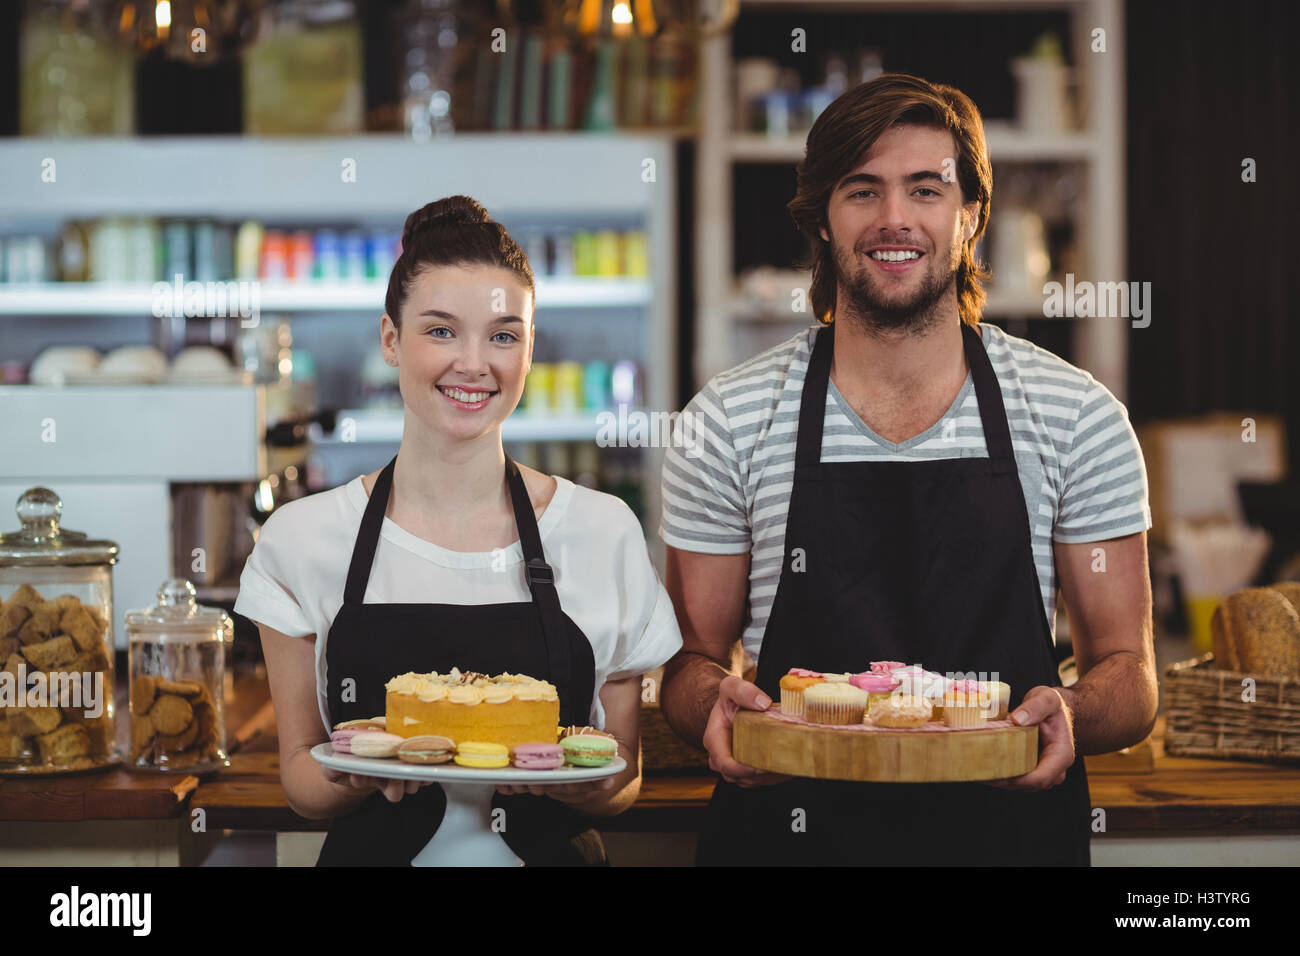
<box><xmin>381</xmin><ymin>265</ymin><xmax>533</xmax><ymax>441</ymax></box>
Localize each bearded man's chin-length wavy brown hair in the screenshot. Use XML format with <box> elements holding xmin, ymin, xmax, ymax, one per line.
<box><xmin>787</xmin><ymin>73</ymin><xmax>993</xmax><ymax>325</ymax></box>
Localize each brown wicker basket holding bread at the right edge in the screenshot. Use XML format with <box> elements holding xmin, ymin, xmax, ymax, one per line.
<box><xmin>1165</xmin><ymin>654</ymin><xmax>1300</xmax><ymax>763</ymax></box>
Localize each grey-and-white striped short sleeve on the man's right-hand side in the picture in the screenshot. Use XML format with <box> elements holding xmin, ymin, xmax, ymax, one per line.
<box><xmin>1052</xmin><ymin>380</ymin><xmax>1151</xmax><ymax>544</ymax></box>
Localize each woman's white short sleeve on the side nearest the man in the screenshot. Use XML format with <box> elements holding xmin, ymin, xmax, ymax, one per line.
<box><xmin>605</xmin><ymin>509</ymin><xmax>681</xmax><ymax>680</ymax></box>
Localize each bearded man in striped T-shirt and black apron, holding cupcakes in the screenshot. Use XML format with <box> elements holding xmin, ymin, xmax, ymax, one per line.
<box><xmin>660</xmin><ymin>74</ymin><xmax>1157</xmax><ymax>865</ymax></box>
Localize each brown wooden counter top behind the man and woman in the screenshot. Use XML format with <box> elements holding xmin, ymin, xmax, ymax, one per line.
<box><xmin>0</xmin><ymin>672</ymin><xmax>1300</xmax><ymax>835</ymax></box>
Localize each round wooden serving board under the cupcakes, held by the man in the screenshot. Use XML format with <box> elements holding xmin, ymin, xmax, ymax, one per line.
<box><xmin>732</xmin><ymin>705</ymin><xmax>1039</xmax><ymax>783</ymax></box>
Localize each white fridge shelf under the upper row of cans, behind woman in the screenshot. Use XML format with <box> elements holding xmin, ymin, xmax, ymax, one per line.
<box><xmin>0</xmin><ymin>277</ymin><xmax>654</xmax><ymax>316</ymax></box>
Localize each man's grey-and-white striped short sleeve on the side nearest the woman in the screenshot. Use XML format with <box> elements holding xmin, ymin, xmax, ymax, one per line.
<box><xmin>659</xmin><ymin>381</ymin><xmax>750</xmax><ymax>554</ymax></box>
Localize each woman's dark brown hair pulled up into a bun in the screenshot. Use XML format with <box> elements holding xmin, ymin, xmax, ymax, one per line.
<box><xmin>384</xmin><ymin>196</ymin><xmax>537</xmax><ymax>330</ymax></box>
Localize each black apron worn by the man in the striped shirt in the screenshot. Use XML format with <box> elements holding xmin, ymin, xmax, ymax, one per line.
<box><xmin>697</xmin><ymin>324</ymin><xmax>1091</xmax><ymax>866</ymax></box>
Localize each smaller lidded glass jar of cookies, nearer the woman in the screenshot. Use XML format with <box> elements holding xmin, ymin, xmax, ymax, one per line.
<box><xmin>126</xmin><ymin>578</ymin><xmax>234</xmax><ymax>774</ymax></box>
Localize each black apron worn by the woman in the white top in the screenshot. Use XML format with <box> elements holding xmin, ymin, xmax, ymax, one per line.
<box><xmin>316</xmin><ymin>455</ymin><xmax>607</xmax><ymax>866</ymax></box>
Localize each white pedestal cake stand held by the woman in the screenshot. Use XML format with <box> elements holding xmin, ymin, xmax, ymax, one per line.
<box><xmin>312</xmin><ymin>743</ymin><xmax>627</xmax><ymax>866</ymax></box>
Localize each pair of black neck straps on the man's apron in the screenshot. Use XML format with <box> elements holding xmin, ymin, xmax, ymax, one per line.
<box><xmin>794</xmin><ymin>323</ymin><xmax>1015</xmax><ymax>468</ymax></box>
